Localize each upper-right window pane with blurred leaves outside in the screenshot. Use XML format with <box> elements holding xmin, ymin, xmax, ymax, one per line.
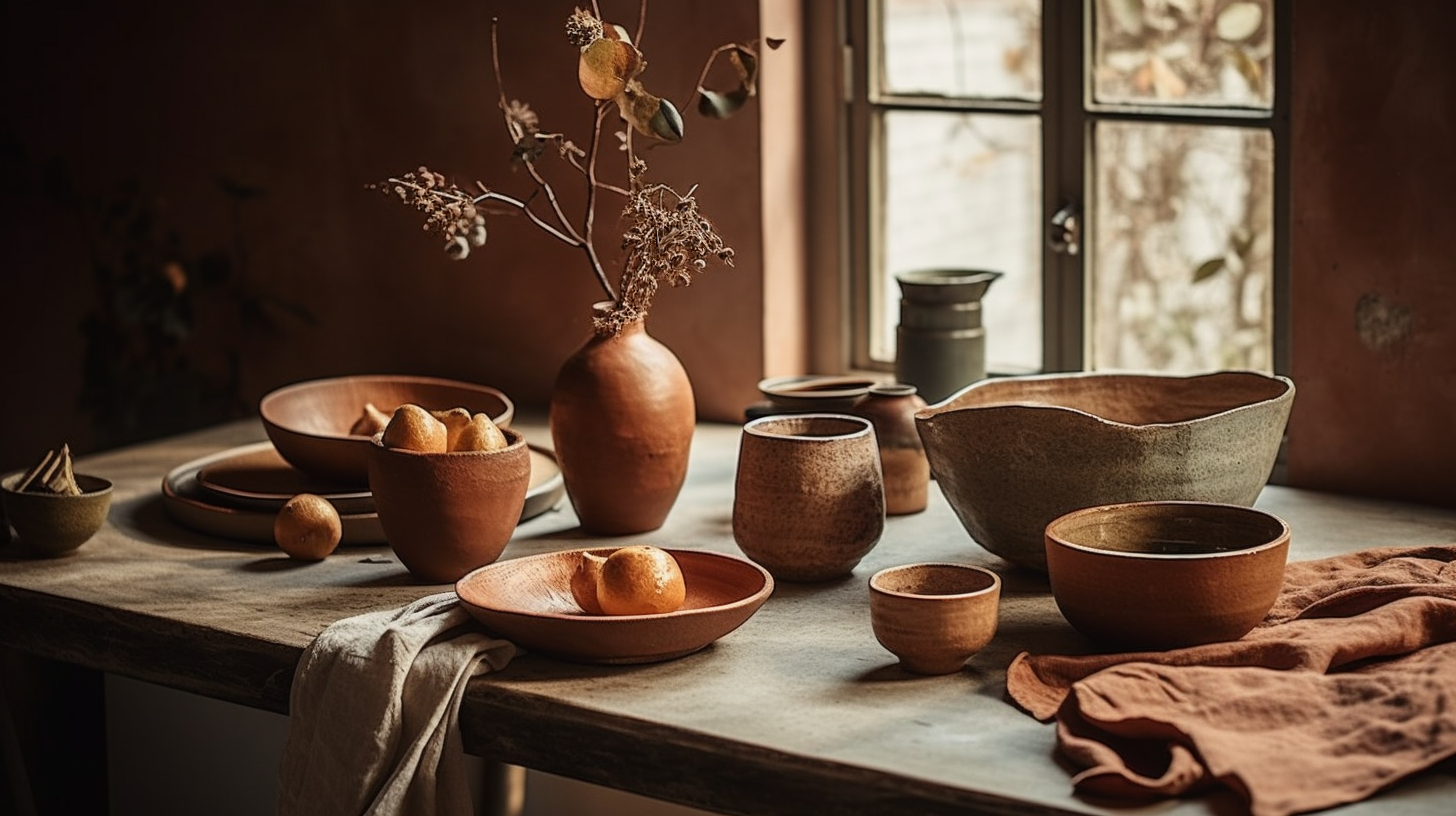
<box><xmin>1092</xmin><ymin>0</ymin><xmax>1274</xmax><ymax>109</ymax></box>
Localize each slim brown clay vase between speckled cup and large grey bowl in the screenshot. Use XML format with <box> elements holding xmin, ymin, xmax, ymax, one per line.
<box><xmin>855</xmin><ymin>383</ymin><xmax>930</xmax><ymax>516</ymax></box>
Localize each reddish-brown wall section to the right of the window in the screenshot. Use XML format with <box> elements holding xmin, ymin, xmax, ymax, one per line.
<box><xmin>1289</xmin><ymin>0</ymin><xmax>1456</xmax><ymax>506</ymax></box>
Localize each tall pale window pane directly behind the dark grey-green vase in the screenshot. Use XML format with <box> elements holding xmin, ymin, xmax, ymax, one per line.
<box><xmin>871</xmin><ymin>111</ymin><xmax>1041</xmax><ymax>372</ymax></box>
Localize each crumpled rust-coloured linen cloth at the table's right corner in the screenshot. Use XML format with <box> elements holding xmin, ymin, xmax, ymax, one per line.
<box><xmin>1006</xmin><ymin>545</ymin><xmax>1456</xmax><ymax>816</ymax></box>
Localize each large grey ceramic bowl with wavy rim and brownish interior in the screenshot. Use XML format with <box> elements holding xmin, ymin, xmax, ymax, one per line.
<box><xmin>916</xmin><ymin>372</ymin><xmax>1294</xmax><ymax>571</ymax></box>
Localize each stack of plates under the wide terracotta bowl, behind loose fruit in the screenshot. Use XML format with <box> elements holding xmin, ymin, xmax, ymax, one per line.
<box><xmin>162</xmin><ymin>442</ymin><xmax>566</xmax><ymax>545</ymax></box>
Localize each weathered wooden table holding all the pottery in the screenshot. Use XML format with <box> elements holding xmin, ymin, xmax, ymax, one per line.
<box><xmin>0</xmin><ymin>421</ymin><xmax>1456</xmax><ymax>816</ymax></box>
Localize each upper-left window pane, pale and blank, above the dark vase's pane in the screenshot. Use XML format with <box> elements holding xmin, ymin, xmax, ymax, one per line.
<box><xmin>879</xmin><ymin>0</ymin><xmax>1041</xmax><ymax>99</ymax></box>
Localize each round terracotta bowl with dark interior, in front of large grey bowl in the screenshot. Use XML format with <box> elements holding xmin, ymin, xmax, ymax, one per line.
<box><xmin>1045</xmin><ymin>501</ymin><xmax>1289</xmax><ymax>650</ymax></box>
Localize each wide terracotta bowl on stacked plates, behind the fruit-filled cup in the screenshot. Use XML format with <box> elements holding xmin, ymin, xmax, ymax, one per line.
<box><xmin>258</xmin><ymin>374</ymin><xmax>515</xmax><ymax>485</ymax></box>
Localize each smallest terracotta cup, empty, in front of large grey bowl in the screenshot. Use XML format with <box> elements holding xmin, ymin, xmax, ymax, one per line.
<box><xmin>869</xmin><ymin>564</ymin><xmax>1000</xmax><ymax>675</ymax></box>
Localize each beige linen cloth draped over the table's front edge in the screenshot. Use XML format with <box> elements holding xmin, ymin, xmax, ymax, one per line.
<box><xmin>278</xmin><ymin>592</ymin><xmax>515</xmax><ymax>816</ymax></box>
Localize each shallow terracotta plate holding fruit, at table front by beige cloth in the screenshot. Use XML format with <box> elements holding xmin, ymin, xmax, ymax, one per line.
<box><xmin>456</xmin><ymin>548</ymin><xmax>773</xmax><ymax>663</ymax></box>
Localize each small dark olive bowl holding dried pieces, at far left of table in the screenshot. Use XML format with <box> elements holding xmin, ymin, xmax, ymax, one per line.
<box><xmin>0</xmin><ymin>474</ymin><xmax>111</xmax><ymax>557</ymax></box>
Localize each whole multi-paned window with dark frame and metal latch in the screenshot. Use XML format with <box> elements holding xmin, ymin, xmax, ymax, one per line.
<box><xmin>846</xmin><ymin>0</ymin><xmax>1289</xmax><ymax>373</ymax></box>
